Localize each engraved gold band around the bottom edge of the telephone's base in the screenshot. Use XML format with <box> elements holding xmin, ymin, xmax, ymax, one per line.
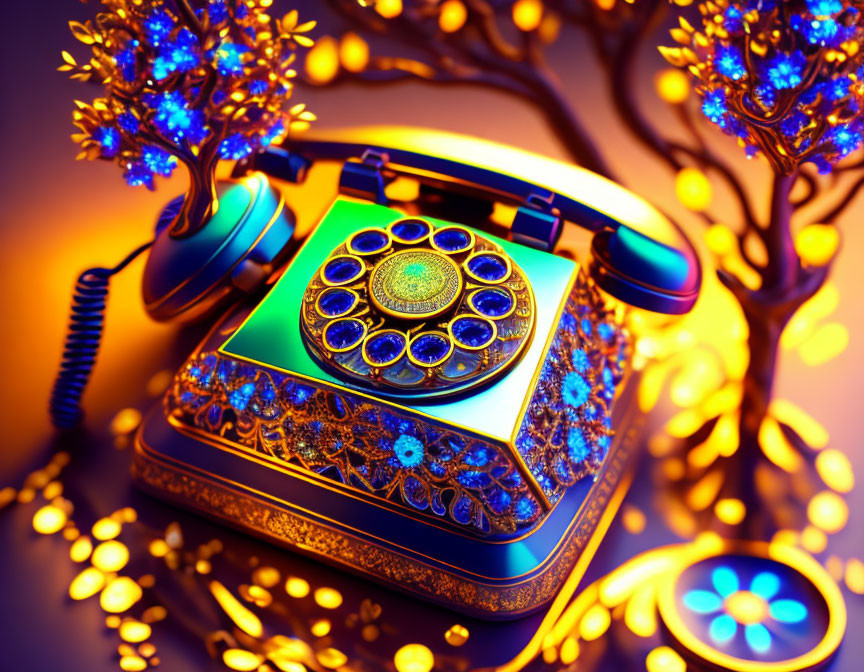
<box><xmin>132</xmin><ymin>418</ymin><xmax>641</xmax><ymax>618</ymax></box>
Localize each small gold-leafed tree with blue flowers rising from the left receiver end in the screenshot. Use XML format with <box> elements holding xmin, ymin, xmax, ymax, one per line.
<box><xmin>59</xmin><ymin>0</ymin><xmax>315</xmax><ymax>236</ymax></box>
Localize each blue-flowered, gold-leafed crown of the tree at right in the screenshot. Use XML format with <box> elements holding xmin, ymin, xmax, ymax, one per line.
<box><xmin>676</xmin><ymin>0</ymin><xmax>864</xmax><ymax>174</ymax></box>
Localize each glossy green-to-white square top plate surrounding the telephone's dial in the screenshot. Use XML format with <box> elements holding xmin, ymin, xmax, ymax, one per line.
<box><xmin>221</xmin><ymin>198</ymin><xmax>576</xmax><ymax>443</ymax></box>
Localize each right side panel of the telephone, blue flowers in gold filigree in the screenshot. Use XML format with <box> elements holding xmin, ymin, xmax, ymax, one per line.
<box><xmin>516</xmin><ymin>270</ymin><xmax>628</xmax><ymax>503</ymax></box>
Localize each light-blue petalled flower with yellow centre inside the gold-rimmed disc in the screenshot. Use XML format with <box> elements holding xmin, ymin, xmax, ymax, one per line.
<box><xmin>683</xmin><ymin>565</ymin><xmax>807</xmax><ymax>654</ymax></box>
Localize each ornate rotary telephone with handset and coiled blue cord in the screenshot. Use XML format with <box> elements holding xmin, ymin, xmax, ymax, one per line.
<box><xmin>51</xmin><ymin>127</ymin><xmax>701</xmax><ymax>617</ymax></box>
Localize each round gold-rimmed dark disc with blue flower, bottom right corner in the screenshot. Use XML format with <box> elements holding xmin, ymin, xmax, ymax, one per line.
<box><xmin>659</xmin><ymin>542</ymin><xmax>845</xmax><ymax>672</ymax></box>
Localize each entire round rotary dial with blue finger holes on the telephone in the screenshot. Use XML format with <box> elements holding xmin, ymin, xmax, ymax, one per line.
<box><xmin>300</xmin><ymin>217</ymin><xmax>534</xmax><ymax>397</ymax></box>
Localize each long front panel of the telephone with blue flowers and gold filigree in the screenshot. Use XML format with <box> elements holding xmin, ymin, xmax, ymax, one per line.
<box><xmin>166</xmin><ymin>352</ymin><xmax>541</xmax><ymax>534</ymax></box>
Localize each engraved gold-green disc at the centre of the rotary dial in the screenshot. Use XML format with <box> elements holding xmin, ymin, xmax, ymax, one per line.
<box><xmin>369</xmin><ymin>249</ymin><xmax>463</xmax><ymax>320</ymax></box>
